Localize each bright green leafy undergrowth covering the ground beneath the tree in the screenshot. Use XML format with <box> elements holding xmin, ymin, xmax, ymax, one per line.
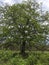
<box><xmin>0</xmin><ymin>50</ymin><xmax>49</xmax><ymax>65</ymax></box>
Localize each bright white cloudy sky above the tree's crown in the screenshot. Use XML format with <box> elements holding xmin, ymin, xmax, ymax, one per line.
<box><xmin>0</xmin><ymin>0</ymin><xmax>49</xmax><ymax>10</ymax></box>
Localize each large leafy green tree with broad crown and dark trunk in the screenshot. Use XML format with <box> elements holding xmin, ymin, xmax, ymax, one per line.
<box><xmin>0</xmin><ymin>0</ymin><xmax>45</xmax><ymax>54</ymax></box>
